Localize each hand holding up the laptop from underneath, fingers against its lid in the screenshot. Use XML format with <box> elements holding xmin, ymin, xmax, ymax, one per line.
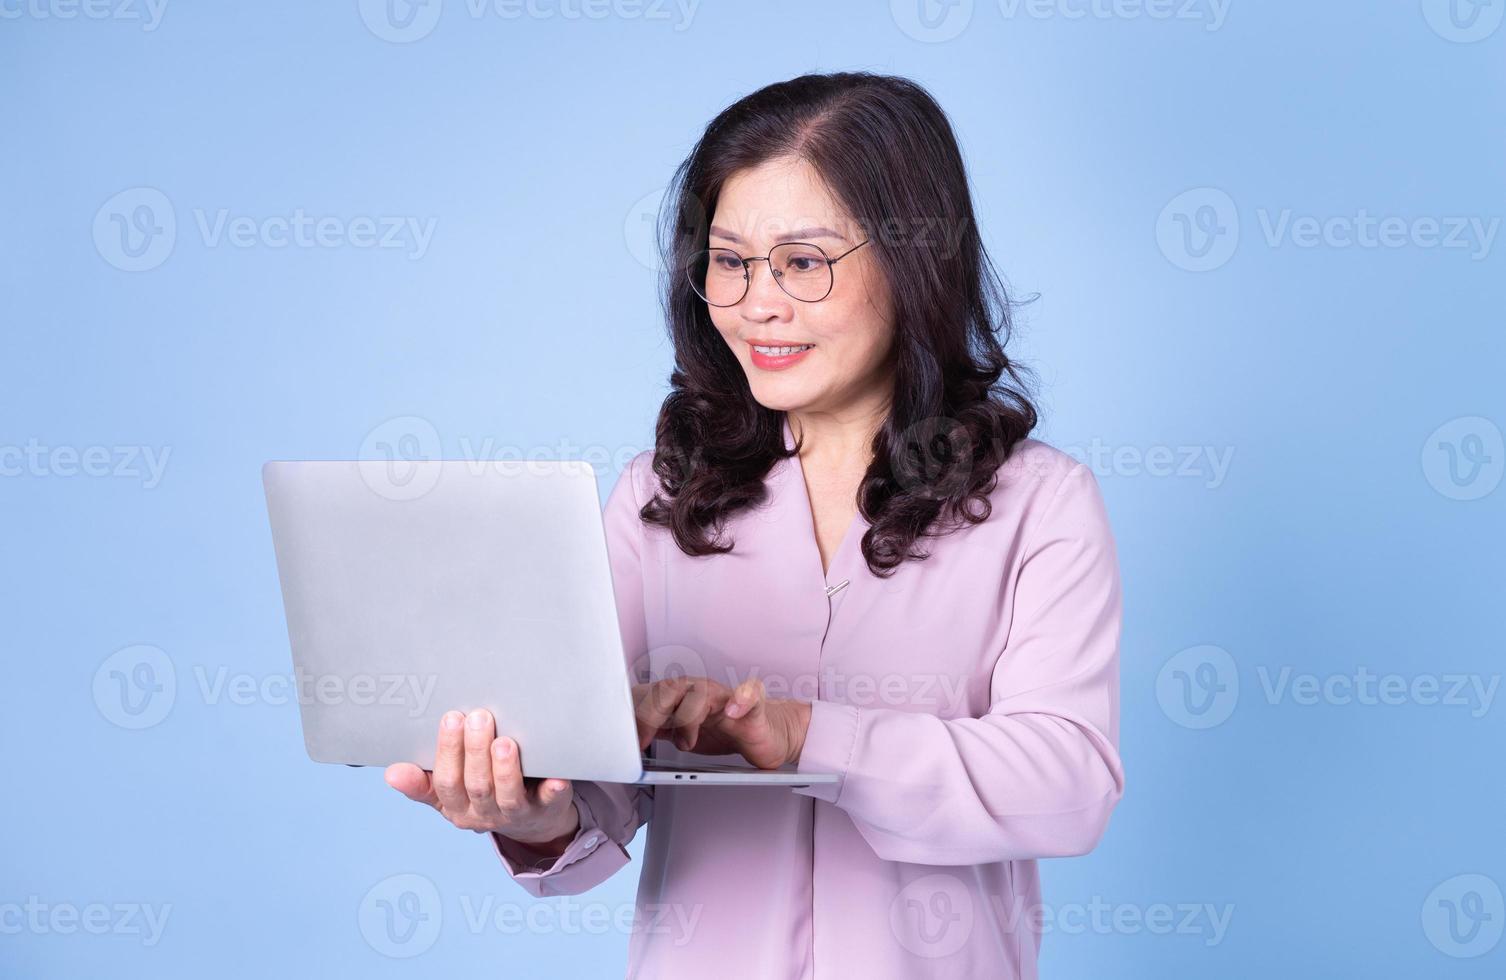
<box><xmin>387</xmin><ymin>709</ymin><xmax>580</xmax><ymax>855</ymax></box>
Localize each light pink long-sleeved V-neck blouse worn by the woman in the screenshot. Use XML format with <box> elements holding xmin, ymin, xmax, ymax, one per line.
<box><xmin>491</xmin><ymin>409</ymin><xmax>1123</xmax><ymax>980</ymax></box>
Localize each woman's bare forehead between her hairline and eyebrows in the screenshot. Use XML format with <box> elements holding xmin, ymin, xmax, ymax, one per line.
<box><xmin>711</xmin><ymin>158</ymin><xmax>849</xmax><ymax>244</ymax></box>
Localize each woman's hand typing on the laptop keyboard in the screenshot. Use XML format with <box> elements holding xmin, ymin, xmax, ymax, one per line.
<box><xmin>633</xmin><ymin>677</ymin><xmax>810</xmax><ymax>769</ymax></box>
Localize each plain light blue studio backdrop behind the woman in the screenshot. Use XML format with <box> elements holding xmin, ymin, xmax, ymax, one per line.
<box><xmin>0</xmin><ymin>0</ymin><xmax>1506</xmax><ymax>978</ymax></box>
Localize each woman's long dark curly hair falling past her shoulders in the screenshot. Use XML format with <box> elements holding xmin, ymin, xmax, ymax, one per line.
<box><xmin>640</xmin><ymin>72</ymin><xmax>1038</xmax><ymax>577</ymax></box>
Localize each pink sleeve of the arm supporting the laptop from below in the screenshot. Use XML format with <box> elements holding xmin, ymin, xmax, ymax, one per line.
<box><xmin>488</xmin><ymin>450</ymin><xmax>654</xmax><ymax>896</ymax></box>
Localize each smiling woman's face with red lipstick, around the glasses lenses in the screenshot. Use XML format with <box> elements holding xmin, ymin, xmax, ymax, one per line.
<box><xmin>708</xmin><ymin>158</ymin><xmax>895</xmax><ymax>414</ymax></box>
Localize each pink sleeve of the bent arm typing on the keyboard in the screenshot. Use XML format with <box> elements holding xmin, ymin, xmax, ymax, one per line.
<box><xmin>794</xmin><ymin>464</ymin><xmax>1123</xmax><ymax>864</ymax></box>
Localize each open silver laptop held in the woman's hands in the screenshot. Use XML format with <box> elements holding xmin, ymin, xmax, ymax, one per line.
<box><xmin>262</xmin><ymin>459</ymin><xmax>837</xmax><ymax>786</ymax></box>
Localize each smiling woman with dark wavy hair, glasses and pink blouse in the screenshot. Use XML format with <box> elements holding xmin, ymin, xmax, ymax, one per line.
<box><xmin>387</xmin><ymin>72</ymin><xmax>1123</xmax><ymax>978</ymax></box>
